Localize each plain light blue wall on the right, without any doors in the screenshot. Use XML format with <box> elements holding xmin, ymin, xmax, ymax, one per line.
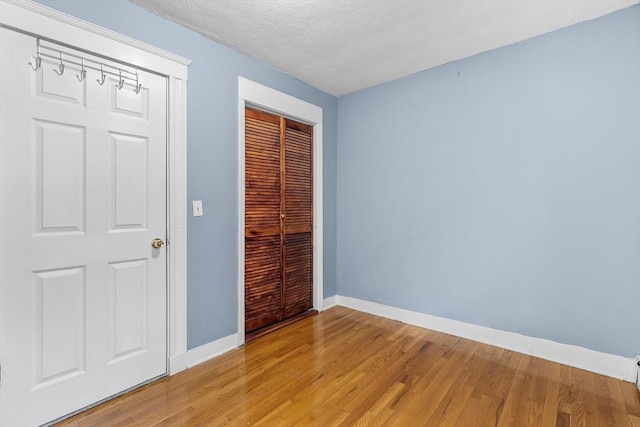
<box><xmin>337</xmin><ymin>6</ymin><xmax>640</xmax><ymax>356</ymax></box>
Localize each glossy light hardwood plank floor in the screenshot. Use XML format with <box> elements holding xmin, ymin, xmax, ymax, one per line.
<box><xmin>57</xmin><ymin>307</ymin><xmax>640</xmax><ymax>427</ymax></box>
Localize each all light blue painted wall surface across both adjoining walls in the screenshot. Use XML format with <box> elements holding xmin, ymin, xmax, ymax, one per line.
<box><xmin>35</xmin><ymin>0</ymin><xmax>640</xmax><ymax>362</ymax></box>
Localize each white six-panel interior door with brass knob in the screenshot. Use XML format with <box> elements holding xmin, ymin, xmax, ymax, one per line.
<box><xmin>0</xmin><ymin>28</ymin><xmax>167</xmax><ymax>426</ymax></box>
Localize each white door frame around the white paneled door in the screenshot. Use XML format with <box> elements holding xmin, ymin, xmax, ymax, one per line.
<box><xmin>0</xmin><ymin>0</ymin><xmax>191</xmax><ymax>376</ymax></box>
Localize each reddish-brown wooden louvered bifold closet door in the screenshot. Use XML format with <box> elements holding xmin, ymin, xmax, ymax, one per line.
<box><xmin>245</xmin><ymin>108</ymin><xmax>313</xmax><ymax>332</ymax></box>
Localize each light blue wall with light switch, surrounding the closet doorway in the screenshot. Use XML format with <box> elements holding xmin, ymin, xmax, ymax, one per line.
<box><xmin>40</xmin><ymin>0</ymin><xmax>337</xmax><ymax>348</ymax></box>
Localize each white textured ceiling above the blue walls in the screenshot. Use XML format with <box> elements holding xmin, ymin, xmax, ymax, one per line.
<box><xmin>131</xmin><ymin>0</ymin><xmax>640</xmax><ymax>96</ymax></box>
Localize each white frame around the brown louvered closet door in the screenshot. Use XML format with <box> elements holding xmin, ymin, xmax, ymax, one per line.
<box><xmin>238</xmin><ymin>77</ymin><xmax>323</xmax><ymax>346</ymax></box>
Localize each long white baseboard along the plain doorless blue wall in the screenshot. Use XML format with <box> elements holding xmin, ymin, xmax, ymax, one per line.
<box><xmin>335</xmin><ymin>295</ymin><xmax>640</xmax><ymax>388</ymax></box>
